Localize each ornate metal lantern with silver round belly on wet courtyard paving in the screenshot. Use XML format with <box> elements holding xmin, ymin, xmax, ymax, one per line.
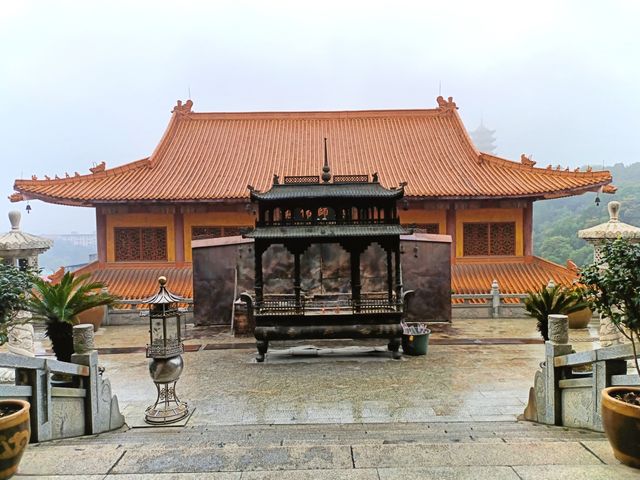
<box><xmin>142</xmin><ymin>277</ymin><xmax>189</xmax><ymax>425</ymax></box>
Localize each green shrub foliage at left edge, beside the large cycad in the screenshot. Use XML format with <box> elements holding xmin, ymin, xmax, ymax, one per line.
<box><xmin>0</xmin><ymin>263</ymin><xmax>36</xmax><ymax>344</ymax></box>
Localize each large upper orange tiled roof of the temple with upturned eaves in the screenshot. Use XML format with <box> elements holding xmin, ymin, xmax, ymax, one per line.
<box><xmin>11</xmin><ymin>97</ymin><xmax>611</xmax><ymax>205</ymax></box>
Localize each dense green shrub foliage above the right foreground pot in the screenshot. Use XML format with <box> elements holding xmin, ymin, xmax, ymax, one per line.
<box><xmin>580</xmin><ymin>238</ymin><xmax>640</xmax><ymax>375</ymax></box>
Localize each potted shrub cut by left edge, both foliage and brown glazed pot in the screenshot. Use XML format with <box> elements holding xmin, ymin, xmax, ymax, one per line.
<box><xmin>0</xmin><ymin>263</ymin><xmax>35</xmax><ymax>479</ymax></box>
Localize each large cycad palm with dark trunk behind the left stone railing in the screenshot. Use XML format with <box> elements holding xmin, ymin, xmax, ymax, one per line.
<box><xmin>27</xmin><ymin>272</ymin><xmax>116</xmax><ymax>362</ymax></box>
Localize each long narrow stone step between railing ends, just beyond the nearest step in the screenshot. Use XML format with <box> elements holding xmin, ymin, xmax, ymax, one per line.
<box><xmin>43</xmin><ymin>422</ymin><xmax>604</xmax><ymax>448</ymax></box>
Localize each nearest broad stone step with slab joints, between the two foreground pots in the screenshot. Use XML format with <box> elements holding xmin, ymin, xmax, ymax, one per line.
<box><xmin>20</xmin><ymin>440</ymin><xmax>624</xmax><ymax>478</ymax></box>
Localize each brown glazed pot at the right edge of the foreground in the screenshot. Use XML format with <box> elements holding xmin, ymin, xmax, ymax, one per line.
<box><xmin>602</xmin><ymin>387</ymin><xmax>640</xmax><ymax>468</ymax></box>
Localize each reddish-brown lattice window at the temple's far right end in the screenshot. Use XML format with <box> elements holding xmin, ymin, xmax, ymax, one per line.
<box><xmin>463</xmin><ymin>222</ymin><xmax>516</xmax><ymax>257</ymax></box>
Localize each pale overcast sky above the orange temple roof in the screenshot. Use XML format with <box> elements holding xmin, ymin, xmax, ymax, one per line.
<box><xmin>0</xmin><ymin>0</ymin><xmax>640</xmax><ymax>233</ymax></box>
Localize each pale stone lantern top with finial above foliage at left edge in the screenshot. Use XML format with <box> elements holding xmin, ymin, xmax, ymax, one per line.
<box><xmin>0</xmin><ymin>210</ymin><xmax>53</xmax><ymax>269</ymax></box>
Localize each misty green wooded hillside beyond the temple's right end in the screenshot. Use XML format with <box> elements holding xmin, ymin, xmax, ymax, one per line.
<box><xmin>533</xmin><ymin>163</ymin><xmax>640</xmax><ymax>265</ymax></box>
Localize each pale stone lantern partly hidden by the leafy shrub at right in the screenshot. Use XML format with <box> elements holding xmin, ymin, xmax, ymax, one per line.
<box><xmin>578</xmin><ymin>201</ymin><xmax>640</xmax><ymax>347</ymax></box>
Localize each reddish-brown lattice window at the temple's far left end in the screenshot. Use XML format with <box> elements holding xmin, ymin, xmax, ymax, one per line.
<box><xmin>114</xmin><ymin>227</ymin><xmax>167</xmax><ymax>262</ymax></box>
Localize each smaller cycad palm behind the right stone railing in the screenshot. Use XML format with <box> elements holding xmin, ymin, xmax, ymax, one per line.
<box><xmin>524</xmin><ymin>285</ymin><xmax>590</xmax><ymax>340</ymax></box>
